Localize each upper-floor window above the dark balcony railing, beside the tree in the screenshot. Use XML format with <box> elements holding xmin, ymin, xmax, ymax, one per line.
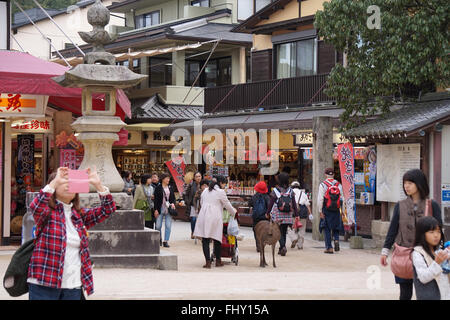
<box><xmin>276</xmin><ymin>39</ymin><xmax>317</xmax><ymax>79</ymax></box>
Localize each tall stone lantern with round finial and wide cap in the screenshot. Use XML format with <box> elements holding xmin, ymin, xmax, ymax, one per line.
<box><xmin>53</xmin><ymin>0</ymin><xmax>147</xmax><ymax>192</ymax></box>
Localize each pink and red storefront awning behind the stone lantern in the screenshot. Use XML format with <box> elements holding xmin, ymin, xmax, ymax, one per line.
<box><xmin>0</xmin><ymin>50</ymin><xmax>131</xmax><ymax>119</ymax></box>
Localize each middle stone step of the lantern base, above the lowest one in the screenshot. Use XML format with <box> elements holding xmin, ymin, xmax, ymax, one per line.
<box><xmin>89</xmin><ymin>228</ymin><xmax>160</xmax><ymax>255</ymax></box>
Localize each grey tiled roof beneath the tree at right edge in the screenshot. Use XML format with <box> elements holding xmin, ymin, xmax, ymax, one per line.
<box><xmin>345</xmin><ymin>93</ymin><xmax>450</xmax><ymax>137</ymax></box>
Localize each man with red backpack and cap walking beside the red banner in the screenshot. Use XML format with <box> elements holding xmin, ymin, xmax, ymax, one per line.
<box><xmin>317</xmin><ymin>168</ymin><xmax>344</xmax><ymax>253</ymax></box>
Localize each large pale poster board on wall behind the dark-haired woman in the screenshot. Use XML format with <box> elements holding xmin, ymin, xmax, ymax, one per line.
<box><xmin>376</xmin><ymin>143</ymin><xmax>420</xmax><ymax>202</ymax></box>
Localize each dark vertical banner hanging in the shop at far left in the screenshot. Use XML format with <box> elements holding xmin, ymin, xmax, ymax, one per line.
<box><xmin>16</xmin><ymin>134</ymin><xmax>34</xmax><ymax>186</ymax></box>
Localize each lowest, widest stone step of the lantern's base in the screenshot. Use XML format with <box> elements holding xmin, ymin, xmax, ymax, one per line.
<box><xmin>91</xmin><ymin>251</ymin><xmax>178</xmax><ymax>270</ymax></box>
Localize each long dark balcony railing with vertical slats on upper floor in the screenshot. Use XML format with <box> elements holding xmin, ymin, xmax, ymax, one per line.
<box><xmin>205</xmin><ymin>74</ymin><xmax>334</xmax><ymax>113</ymax></box>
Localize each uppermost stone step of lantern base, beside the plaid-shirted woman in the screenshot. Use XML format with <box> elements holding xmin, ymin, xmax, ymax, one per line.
<box><xmin>90</xmin><ymin>209</ymin><xmax>145</xmax><ymax>231</ymax></box>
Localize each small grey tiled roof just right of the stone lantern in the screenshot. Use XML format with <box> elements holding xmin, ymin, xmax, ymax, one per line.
<box><xmin>131</xmin><ymin>95</ymin><xmax>203</xmax><ymax>120</ymax></box>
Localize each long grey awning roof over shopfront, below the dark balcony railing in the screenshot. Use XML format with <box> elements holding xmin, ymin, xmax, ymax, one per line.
<box><xmin>161</xmin><ymin>107</ymin><xmax>343</xmax><ymax>135</ymax></box>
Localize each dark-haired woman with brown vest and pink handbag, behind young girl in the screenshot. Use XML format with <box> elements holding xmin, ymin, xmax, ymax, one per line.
<box><xmin>380</xmin><ymin>169</ymin><xmax>442</xmax><ymax>300</ymax></box>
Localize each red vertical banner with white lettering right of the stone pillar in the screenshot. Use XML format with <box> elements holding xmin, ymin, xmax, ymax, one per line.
<box><xmin>337</xmin><ymin>142</ymin><xmax>356</xmax><ymax>228</ymax></box>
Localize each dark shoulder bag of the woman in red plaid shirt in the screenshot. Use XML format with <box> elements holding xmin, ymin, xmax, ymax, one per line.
<box><xmin>3</xmin><ymin>214</ymin><xmax>50</xmax><ymax>297</ymax></box>
